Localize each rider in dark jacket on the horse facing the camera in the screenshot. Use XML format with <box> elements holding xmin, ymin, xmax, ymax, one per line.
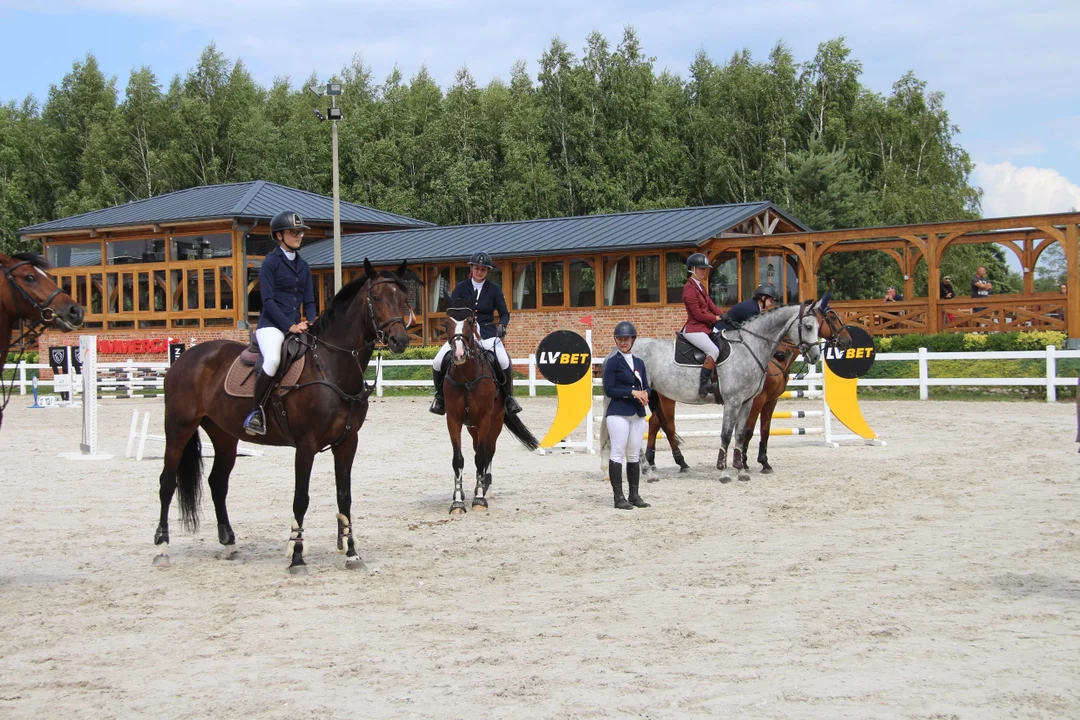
<box><xmin>429</xmin><ymin>253</ymin><xmax>522</xmax><ymax>415</ymax></box>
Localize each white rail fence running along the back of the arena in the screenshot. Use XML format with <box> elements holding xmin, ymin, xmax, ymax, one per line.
<box><xmin>4</xmin><ymin>345</ymin><xmax>1080</xmax><ymax>403</ymax></box>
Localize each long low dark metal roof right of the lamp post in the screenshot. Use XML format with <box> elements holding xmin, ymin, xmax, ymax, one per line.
<box><xmin>303</xmin><ymin>202</ymin><xmax>807</xmax><ymax>268</ymax></box>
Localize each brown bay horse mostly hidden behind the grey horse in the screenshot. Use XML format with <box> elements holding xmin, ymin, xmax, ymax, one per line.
<box><xmin>645</xmin><ymin>298</ymin><xmax>851</xmax><ymax>474</ymax></box>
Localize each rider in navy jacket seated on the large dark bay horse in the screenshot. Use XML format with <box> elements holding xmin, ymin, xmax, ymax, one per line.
<box><xmin>244</xmin><ymin>210</ymin><xmax>315</xmax><ymax>435</ymax></box>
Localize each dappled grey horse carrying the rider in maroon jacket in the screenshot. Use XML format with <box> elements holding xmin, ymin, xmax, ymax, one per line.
<box><xmin>600</xmin><ymin>301</ymin><xmax>821</xmax><ymax>483</ymax></box>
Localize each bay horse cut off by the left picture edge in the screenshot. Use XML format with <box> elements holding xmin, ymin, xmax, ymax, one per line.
<box><xmin>0</xmin><ymin>253</ymin><xmax>85</xmax><ymax>426</ymax></box>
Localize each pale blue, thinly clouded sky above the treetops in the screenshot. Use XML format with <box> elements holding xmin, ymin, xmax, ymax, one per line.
<box><xmin>0</xmin><ymin>0</ymin><xmax>1080</xmax><ymax>246</ymax></box>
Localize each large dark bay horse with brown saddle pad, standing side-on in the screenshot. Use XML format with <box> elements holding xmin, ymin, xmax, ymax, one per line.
<box><xmin>153</xmin><ymin>258</ymin><xmax>414</xmax><ymax>574</ymax></box>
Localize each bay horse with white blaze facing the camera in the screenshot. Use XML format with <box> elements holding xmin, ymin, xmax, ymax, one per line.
<box><xmin>443</xmin><ymin>303</ymin><xmax>540</xmax><ymax>515</ymax></box>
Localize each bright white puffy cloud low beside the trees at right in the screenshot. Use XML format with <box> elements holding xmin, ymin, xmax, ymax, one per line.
<box><xmin>974</xmin><ymin>162</ymin><xmax>1080</xmax><ymax>217</ymax></box>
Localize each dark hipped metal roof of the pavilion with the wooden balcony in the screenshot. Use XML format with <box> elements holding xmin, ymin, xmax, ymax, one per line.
<box><xmin>18</xmin><ymin>180</ymin><xmax>432</xmax><ymax>235</ymax></box>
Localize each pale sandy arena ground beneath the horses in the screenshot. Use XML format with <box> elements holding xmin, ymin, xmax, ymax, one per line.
<box><xmin>0</xmin><ymin>396</ymin><xmax>1080</xmax><ymax>720</ymax></box>
